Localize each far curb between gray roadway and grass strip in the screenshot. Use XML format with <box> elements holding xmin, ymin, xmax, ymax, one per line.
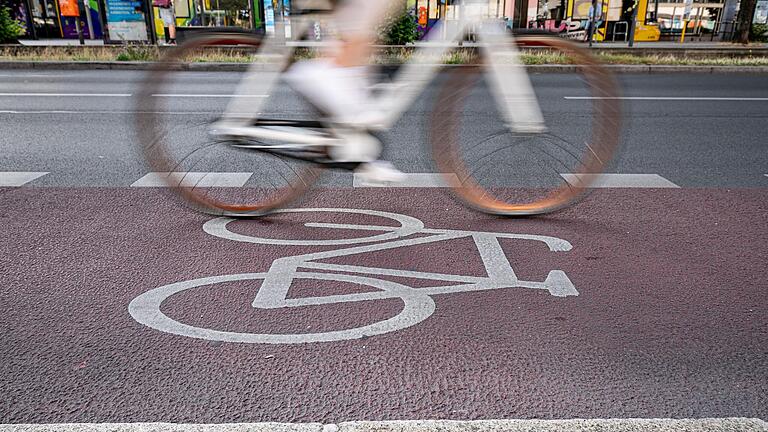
<box><xmin>0</xmin><ymin>61</ymin><xmax>768</xmax><ymax>74</ymax></box>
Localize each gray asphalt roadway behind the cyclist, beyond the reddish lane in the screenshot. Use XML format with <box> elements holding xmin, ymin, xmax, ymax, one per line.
<box><xmin>0</xmin><ymin>71</ymin><xmax>768</xmax><ymax>187</ymax></box>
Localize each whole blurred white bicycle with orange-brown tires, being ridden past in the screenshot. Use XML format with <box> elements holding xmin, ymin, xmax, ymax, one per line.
<box><xmin>136</xmin><ymin>0</ymin><xmax>621</xmax><ymax>216</ymax></box>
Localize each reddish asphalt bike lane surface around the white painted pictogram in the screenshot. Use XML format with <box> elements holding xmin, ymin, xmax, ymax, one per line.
<box><xmin>0</xmin><ymin>188</ymin><xmax>768</xmax><ymax>423</ymax></box>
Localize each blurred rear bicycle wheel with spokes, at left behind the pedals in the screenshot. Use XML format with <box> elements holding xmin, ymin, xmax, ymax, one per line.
<box><xmin>135</xmin><ymin>33</ymin><xmax>319</xmax><ymax>216</ymax></box>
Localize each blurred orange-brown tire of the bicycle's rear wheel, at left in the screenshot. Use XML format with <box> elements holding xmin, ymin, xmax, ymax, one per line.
<box><xmin>135</xmin><ymin>32</ymin><xmax>320</xmax><ymax>217</ymax></box>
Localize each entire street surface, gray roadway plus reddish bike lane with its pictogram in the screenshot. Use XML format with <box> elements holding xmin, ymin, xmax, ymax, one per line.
<box><xmin>0</xmin><ymin>71</ymin><xmax>768</xmax><ymax>426</ymax></box>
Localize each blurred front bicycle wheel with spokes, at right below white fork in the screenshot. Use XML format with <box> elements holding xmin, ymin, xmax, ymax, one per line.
<box><xmin>430</xmin><ymin>35</ymin><xmax>621</xmax><ymax>216</ymax></box>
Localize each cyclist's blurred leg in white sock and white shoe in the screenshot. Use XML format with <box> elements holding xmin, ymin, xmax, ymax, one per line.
<box><xmin>285</xmin><ymin>0</ymin><xmax>404</xmax><ymax>183</ymax></box>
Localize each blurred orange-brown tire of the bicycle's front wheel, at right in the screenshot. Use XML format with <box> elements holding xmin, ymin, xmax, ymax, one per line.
<box><xmin>430</xmin><ymin>35</ymin><xmax>621</xmax><ymax>216</ymax></box>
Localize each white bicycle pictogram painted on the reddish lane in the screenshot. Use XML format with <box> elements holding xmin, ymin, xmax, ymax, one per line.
<box><xmin>128</xmin><ymin>208</ymin><xmax>579</xmax><ymax>344</ymax></box>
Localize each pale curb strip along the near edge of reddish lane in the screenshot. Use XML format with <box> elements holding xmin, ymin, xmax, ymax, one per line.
<box><xmin>0</xmin><ymin>418</ymin><xmax>768</xmax><ymax>432</ymax></box>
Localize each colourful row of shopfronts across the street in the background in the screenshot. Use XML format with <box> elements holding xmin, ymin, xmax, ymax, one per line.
<box><xmin>7</xmin><ymin>0</ymin><xmax>768</xmax><ymax>43</ymax></box>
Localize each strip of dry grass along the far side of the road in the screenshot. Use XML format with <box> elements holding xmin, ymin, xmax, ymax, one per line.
<box><xmin>0</xmin><ymin>45</ymin><xmax>768</xmax><ymax>66</ymax></box>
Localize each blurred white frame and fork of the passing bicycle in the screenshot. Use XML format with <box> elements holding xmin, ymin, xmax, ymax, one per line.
<box><xmin>212</xmin><ymin>0</ymin><xmax>546</xmax><ymax>145</ymax></box>
